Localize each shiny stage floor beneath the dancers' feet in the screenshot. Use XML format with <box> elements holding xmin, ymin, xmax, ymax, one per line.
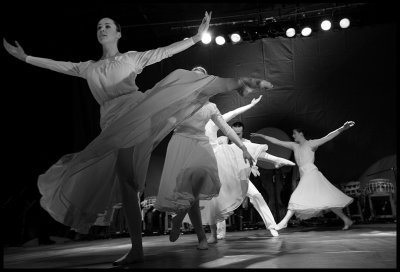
<box><xmin>3</xmin><ymin>223</ymin><xmax>397</xmax><ymax>269</ymax></box>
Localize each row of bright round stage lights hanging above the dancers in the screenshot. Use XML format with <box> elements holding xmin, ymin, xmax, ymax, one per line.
<box><xmin>185</xmin><ymin>18</ymin><xmax>350</xmax><ymax>45</ymax></box>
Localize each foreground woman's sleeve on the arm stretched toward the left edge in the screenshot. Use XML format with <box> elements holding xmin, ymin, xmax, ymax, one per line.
<box><xmin>26</xmin><ymin>56</ymin><xmax>92</xmax><ymax>78</ymax></box>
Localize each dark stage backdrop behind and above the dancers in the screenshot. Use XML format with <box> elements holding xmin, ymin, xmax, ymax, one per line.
<box><xmin>1</xmin><ymin>1</ymin><xmax>397</xmax><ymax>244</ymax></box>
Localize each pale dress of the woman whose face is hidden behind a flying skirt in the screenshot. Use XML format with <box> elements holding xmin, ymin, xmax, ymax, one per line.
<box><xmin>154</xmin><ymin>102</ymin><xmax>233</xmax><ymax>213</ymax></box>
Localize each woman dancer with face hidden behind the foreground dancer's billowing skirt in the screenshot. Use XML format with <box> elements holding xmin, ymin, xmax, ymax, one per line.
<box><xmin>154</xmin><ymin>67</ymin><xmax>272</xmax><ymax>250</ymax></box>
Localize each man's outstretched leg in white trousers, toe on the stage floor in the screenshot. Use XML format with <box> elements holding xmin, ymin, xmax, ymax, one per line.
<box><xmin>247</xmin><ymin>180</ymin><xmax>279</xmax><ymax>236</ymax></box>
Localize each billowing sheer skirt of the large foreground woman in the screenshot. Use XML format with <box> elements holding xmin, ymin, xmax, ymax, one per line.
<box><xmin>38</xmin><ymin>69</ymin><xmax>231</xmax><ymax>233</ymax></box>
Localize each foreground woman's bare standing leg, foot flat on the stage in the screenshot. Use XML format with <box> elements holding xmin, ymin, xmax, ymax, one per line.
<box><xmin>113</xmin><ymin>147</ymin><xmax>144</xmax><ymax>265</ymax></box>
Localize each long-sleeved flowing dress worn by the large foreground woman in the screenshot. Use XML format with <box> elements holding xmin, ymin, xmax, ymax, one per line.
<box><xmin>32</xmin><ymin>39</ymin><xmax>238</xmax><ymax>233</ymax></box>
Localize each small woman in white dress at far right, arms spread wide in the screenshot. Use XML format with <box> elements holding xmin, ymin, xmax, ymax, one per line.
<box><xmin>251</xmin><ymin>121</ymin><xmax>355</xmax><ymax>230</ymax></box>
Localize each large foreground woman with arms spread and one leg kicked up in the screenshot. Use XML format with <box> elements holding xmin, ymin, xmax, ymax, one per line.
<box><xmin>3</xmin><ymin>12</ymin><xmax>270</xmax><ymax>265</ymax></box>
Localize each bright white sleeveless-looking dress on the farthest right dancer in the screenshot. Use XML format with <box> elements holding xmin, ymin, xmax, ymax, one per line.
<box><xmin>288</xmin><ymin>140</ymin><xmax>353</xmax><ymax>219</ymax></box>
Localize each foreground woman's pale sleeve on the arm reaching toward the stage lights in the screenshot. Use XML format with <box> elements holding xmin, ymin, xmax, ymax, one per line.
<box><xmin>128</xmin><ymin>38</ymin><xmax>194</xmax><ymax>74</ymax></box>
